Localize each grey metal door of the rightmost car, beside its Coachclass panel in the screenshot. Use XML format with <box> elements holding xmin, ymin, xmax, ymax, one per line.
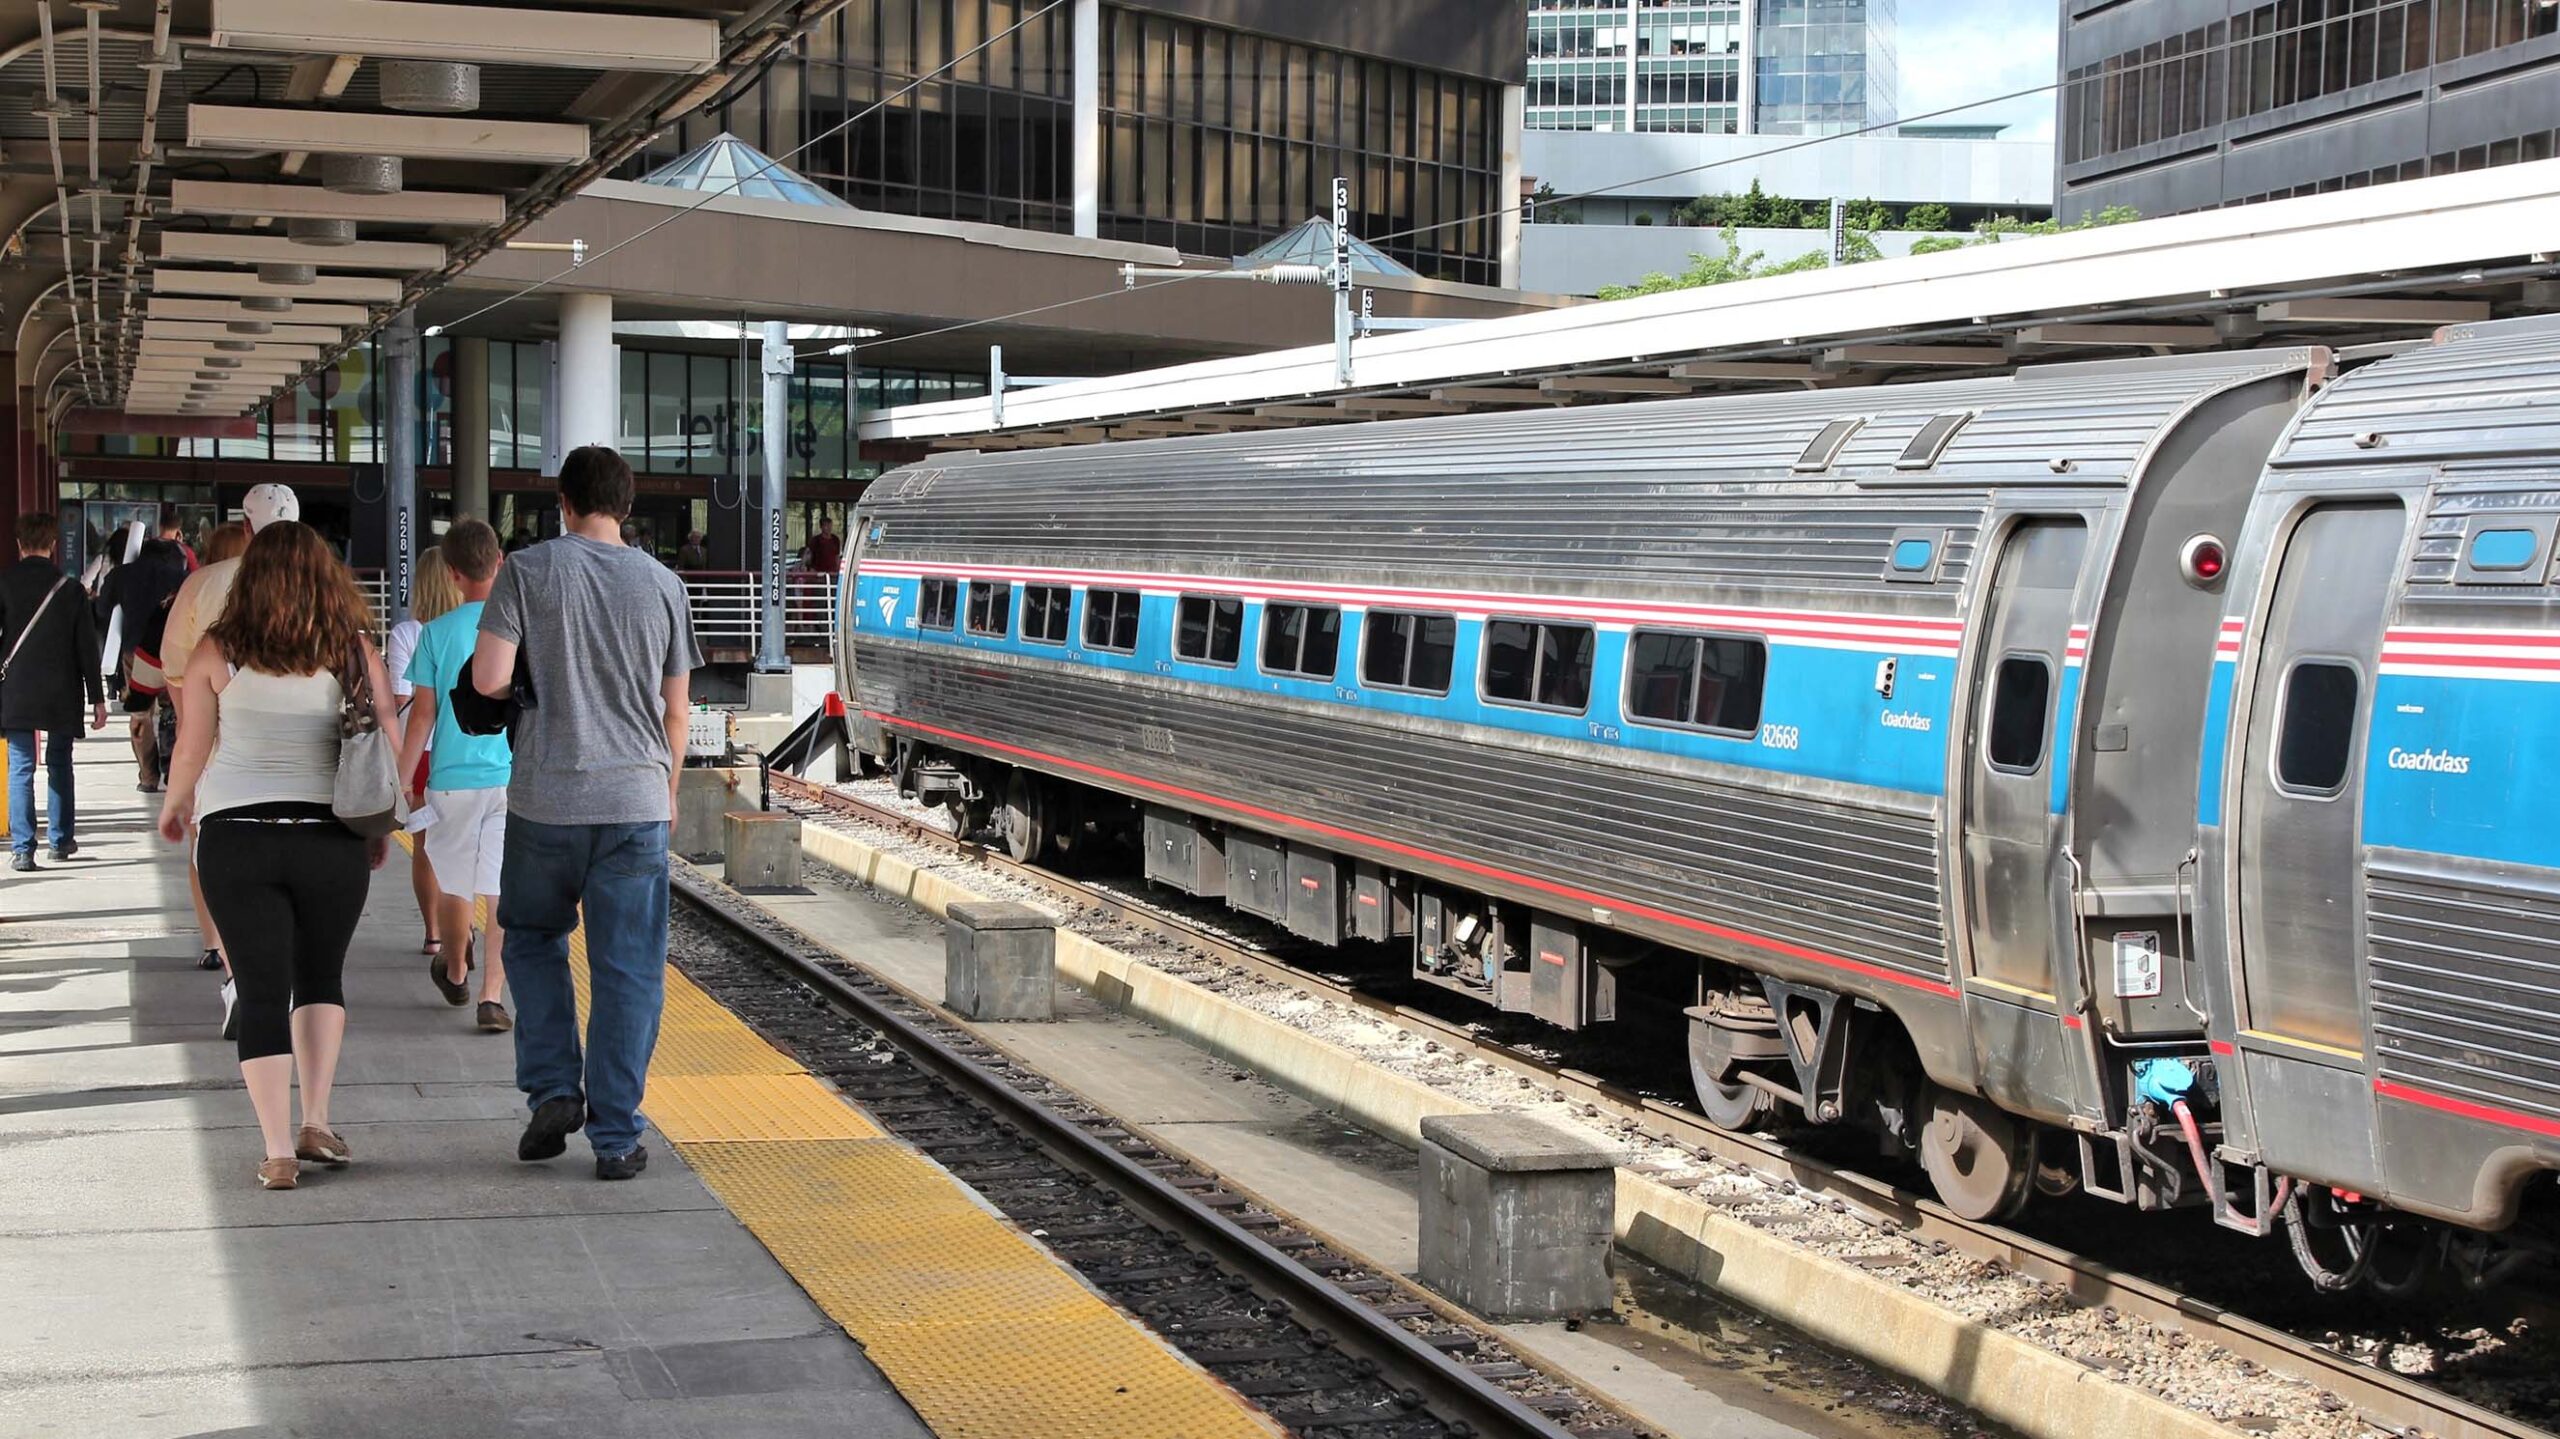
<box><xmin>2232</xmin><ymin>499</ymin><xmax>2409</xmax><ymax>1183</ymax></box>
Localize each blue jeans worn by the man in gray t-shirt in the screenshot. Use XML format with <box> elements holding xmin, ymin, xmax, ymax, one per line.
<box><xmin>497</xmin><ymin>814</ymin><xmax>668</xmax><ymax>1157</ymax></box>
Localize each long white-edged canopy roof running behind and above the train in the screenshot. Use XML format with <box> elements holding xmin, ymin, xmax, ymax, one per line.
<box><xmin>863</xmin><ymin>159</ymin><xmax>2560</xmax><ymax>451</ymax></box>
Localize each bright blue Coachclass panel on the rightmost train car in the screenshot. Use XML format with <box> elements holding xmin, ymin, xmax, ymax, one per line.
<box><xmin>2363</xmin><ymin>673</ymin><xmax>2560</xmax><ymax>868</ymax></box>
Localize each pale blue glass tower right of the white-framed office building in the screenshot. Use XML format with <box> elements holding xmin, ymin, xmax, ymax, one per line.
<box><xmin>1751</xmin><ymin>0</ymin><xmax>1900</xmax><ymax>136</ymax></box>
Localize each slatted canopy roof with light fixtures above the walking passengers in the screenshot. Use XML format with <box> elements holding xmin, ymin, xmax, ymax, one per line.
<box><xmin>0</xmin><ymin>0</ymin><xmax>842</xmax><ymax>433</ymax></box>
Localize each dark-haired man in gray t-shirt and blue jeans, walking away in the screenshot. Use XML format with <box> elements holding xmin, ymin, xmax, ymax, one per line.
<box><xmin>471</xmin><ymin>446</ymin><xmax>701</xmax><ymax>1180</ymax></box>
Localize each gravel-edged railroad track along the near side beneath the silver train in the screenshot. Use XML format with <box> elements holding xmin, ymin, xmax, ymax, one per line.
<box><xmin>768</xmin><ymin>773</ymin><xmax>2552</xmax><ymax>1439</ymax></box>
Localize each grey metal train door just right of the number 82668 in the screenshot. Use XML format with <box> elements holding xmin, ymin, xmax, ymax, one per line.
<box><xmin>1958</xmin><ymin>517</ymin><xmax>2089</xmax><ymax>1116</ymax></box>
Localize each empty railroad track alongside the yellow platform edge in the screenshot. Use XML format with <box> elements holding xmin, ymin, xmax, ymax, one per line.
<box><xmin>673</xmin><ymin>863</ymin><xmax>1638</xmax><ymax>1439</ymax></box>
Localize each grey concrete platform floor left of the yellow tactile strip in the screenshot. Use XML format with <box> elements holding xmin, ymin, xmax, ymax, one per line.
<box><xmin>0</xmin><ymin>740</ymin><xmax>924</xmax><ymax>1439</ymax></box>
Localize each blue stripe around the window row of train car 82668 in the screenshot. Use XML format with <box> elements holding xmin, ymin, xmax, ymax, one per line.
<box><xmin>852</xmin><ymin>574</ymin><xmax>1955</xmax><ymax>796</ymax></box>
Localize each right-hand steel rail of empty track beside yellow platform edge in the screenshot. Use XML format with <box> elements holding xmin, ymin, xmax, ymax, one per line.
<box><xmin>671</xmin><ymin>865</ymin><xmax>1572</xmax><ymax>1439</ymax></box>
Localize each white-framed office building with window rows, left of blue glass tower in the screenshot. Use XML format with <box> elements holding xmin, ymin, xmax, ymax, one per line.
<box><xmin>1526</xmin><ymin>0</ymin><xmax>1748</xmax><ymax>136</ymax></box>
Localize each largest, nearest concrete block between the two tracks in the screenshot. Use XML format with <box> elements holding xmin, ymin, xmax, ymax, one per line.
<box><xmin>1418</xmin><ymin>1114</ymin><xmax>1626</xmax><ymax>1321</ymax></box>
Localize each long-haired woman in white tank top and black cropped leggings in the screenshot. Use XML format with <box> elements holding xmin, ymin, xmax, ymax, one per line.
<box><xmin>159</xmin><ymin>520</ymin><xmax>399</xmax><ymax>1188</ymax></box>
